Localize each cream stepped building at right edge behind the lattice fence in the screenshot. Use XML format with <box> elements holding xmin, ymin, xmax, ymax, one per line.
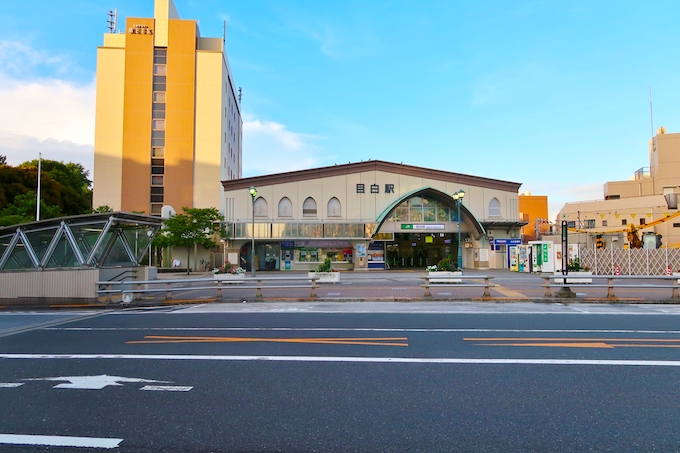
<box><xmin>556</xmin><ymin>127</ymin><xmax>680</xmax><ymax>248</ymax></box>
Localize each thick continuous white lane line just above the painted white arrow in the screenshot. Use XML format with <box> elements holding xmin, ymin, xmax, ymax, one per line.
<box><xmin>0</xmin><ymin>354</ymin><xmax>680</xmax><ymax>367</ymax></box>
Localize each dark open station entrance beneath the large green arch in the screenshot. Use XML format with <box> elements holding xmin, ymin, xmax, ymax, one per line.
<box><xmin>386</xmin><ymin>233</ymin><xmax>458</xmax><ymax>269</ymax></box>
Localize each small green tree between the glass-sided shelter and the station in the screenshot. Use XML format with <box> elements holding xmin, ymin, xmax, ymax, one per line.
<box><xmin>153</xmin><ymin>207</ymin><xmax>224</xmax><ymax>274</ymax></box>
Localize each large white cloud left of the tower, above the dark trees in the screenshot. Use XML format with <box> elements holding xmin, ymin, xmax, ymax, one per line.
<box><xmin>0</xmin><ymin>41</ymin><xmax>95</xmax><ymax>170</ymax></box>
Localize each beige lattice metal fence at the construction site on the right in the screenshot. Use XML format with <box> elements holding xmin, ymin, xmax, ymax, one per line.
<box><xmin>580</xmin><ymin>248</ymin><xmax>680</xmax><ymax>275</ymax></box>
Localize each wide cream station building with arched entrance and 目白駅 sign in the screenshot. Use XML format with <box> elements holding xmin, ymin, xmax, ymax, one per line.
<box><xmin>222</xmin><ymin>160</ymin><xmax>526</xmax><ymax>271</ymax></box>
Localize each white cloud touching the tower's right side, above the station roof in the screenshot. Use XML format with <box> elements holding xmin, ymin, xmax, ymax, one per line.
<box><xmin>243</xmin><ymin>120</ymin><xmax>332</xmax><ymax>176</ymax></box>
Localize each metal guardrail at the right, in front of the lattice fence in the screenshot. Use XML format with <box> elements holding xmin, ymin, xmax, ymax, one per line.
<box><xmin>541</xmin><ymin>274</ymin><xmax>680</xmax><ymax>299</ymax></box>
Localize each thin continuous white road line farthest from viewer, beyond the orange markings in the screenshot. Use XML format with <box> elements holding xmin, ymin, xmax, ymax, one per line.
<box><xmin>46</xmin><ymin>327</ymin><xmax>680</xmax><ymax>334</ymax></box>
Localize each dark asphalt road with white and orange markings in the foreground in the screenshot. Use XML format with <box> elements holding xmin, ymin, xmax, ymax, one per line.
<box><xmin>0</xmin><ymin>303</ymin><xmax>680</xmax><ymax>452</ymax></box>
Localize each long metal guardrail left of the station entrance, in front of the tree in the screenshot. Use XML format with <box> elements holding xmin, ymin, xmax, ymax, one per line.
<box><xmin>95</xmin><ymin>276</ymin><xmax>319</xmax><ymax>304</ymax></box>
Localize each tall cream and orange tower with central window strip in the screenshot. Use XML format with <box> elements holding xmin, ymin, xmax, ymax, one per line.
<box><xmin>93</xmin><ymin>0</ymin><xmax>243</xmax><ymax>215</ymax></box>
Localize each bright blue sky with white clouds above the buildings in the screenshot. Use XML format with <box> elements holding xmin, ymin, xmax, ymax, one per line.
<box><xmin>0</xmin><ymin>0</ymin><xmax>680</xmax><ymax>219</ymax></box>
